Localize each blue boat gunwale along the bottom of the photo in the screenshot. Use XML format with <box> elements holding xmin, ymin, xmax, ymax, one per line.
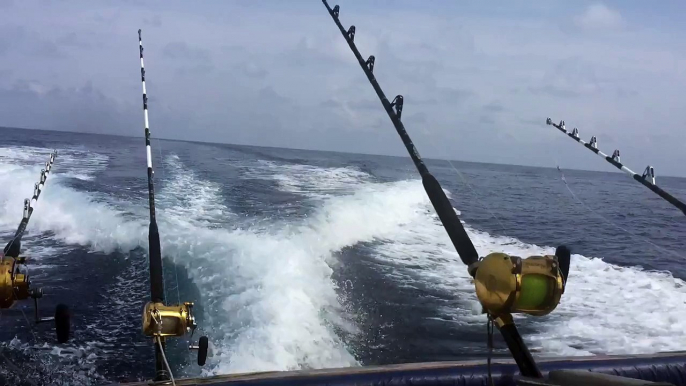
<box><xmin>125</xmin><ymin>351</ymin><xmax>686</xmax><ymax>386</ymax></box>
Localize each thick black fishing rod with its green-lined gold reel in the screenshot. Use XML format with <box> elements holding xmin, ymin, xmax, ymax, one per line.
<box><xmin>322</xmin><ymin>0</ymin><xmax>571</xmax><ymax>378</ymax></box>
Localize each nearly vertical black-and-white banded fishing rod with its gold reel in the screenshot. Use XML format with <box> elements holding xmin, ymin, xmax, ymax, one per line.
<box><xmin>138</xmin><ymin>29</ymin><xmax>209</xmax><ymax>384</ymax></box>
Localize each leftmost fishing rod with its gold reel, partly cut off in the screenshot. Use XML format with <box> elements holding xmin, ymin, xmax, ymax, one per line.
<box><xmin>0</xmin><ymin>150</ymin><xmax>71</xmax><ymax>343</ymax></box>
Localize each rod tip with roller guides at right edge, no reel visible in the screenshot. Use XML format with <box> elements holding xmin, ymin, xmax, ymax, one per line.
<box><xmin>546</xmin><ymin>118</ymin><xmax>686</xmax><ymax>215</ymax></box>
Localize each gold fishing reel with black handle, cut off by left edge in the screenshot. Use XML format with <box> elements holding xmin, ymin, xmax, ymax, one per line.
<box><xmin>0</xmin><ymin>255</ymin><xmax>71</xmax><ymax>343</ymax></box>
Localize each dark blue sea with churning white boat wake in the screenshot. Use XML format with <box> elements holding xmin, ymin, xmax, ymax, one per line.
<box><xmin>0</xmin><ymin>129</ymin><xmax>686</xmax><ymax>385</ymax></box>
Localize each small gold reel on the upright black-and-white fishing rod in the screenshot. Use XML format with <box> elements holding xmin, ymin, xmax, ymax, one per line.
<box><xmin>143</xmin><ymin>302</ymin><xmax>209</xmax><ymax>366</ymax></box>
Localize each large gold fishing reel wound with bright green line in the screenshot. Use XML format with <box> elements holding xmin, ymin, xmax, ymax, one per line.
<box><xmin>471</xmin><ymin>248</ymin><xmax>569</xmax><ymax>319</ymax></box>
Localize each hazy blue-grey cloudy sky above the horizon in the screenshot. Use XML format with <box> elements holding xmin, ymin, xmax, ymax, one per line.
<box><xmin>0</xmin><ymin>0</ymin><xmax>686</xmax><ymax>176</ymax></box>
